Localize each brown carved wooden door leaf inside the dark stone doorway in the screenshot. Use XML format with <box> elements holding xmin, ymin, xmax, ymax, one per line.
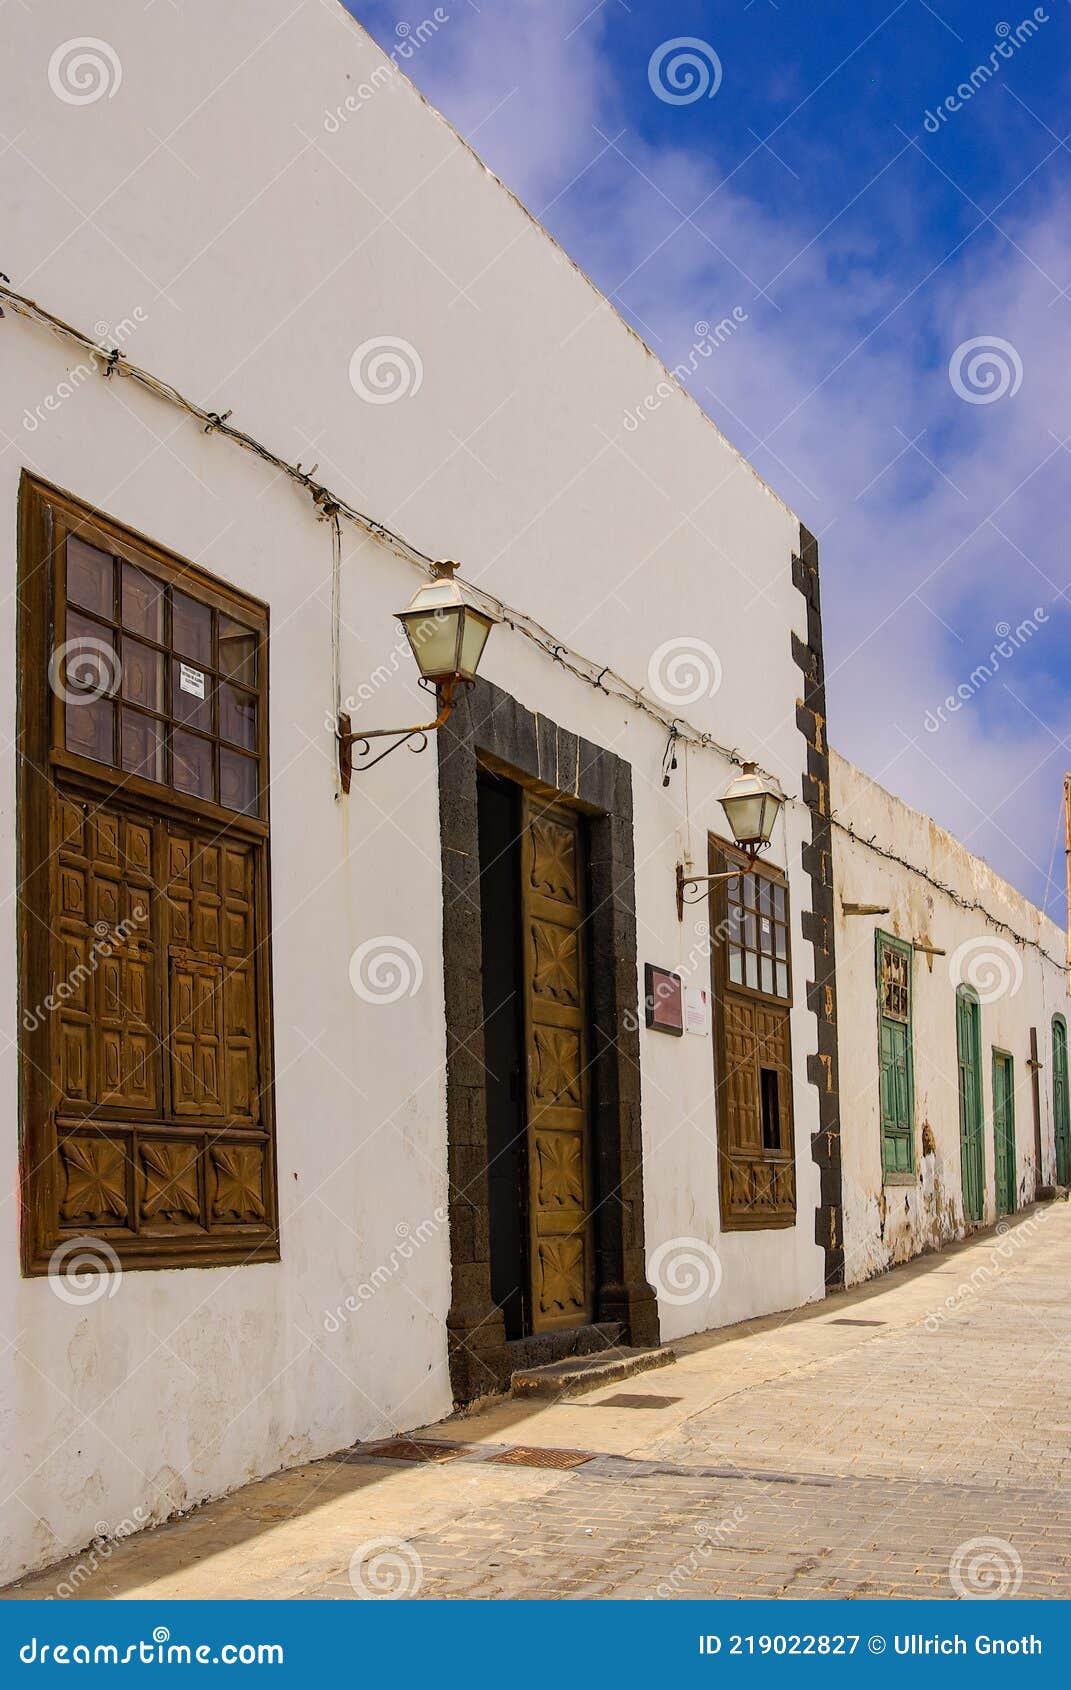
<box><xmin>520</xmin><ymin>793</ymin><xmax>595</xmax><ymax>1332</ymax></box>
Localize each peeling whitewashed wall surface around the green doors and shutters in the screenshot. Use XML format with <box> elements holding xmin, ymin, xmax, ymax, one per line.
<box><xmin>829</xmin><ymin>752</ymin><xmax>1071</xmax><ymax>1284</ymax></box>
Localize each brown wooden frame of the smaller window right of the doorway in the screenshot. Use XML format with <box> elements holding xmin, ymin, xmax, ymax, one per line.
<box><xmin>708</xmin><ymin>833</ymin><xmax>799</xmax><ymax>1232</ymax></box>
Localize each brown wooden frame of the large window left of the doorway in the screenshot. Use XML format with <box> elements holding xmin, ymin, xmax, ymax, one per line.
<box><xmin>17</xmin><ymin>472</ymin><xmax>279</xmax><ymax>1276</ymax></box>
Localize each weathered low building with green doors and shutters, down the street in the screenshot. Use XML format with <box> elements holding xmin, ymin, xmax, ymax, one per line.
<box><xmin>831</xmin><ymin>752</ymin><xmax>1071</xmax><ymax>1284</ymax></box>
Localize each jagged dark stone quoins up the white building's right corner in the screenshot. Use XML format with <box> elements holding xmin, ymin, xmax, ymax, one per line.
<box><xmin>792</xmin><ymin>526</ymin><xmax>845</xmax><ymax>1286</ymax></box>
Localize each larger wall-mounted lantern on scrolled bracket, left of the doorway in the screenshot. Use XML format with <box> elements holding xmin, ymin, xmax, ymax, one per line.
<box><xmin>338</xmin><ymin>561</ymin><xmax>498</xmax><ymax>793</ymax></box>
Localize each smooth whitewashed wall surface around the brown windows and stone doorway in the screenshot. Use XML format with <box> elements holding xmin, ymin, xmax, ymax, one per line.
<box><xmin>0</xmin><ymin>0</ymin><xmax>823</xmax><ymax>1577</ymax></box>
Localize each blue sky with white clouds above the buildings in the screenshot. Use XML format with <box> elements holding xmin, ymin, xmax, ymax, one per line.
<box><xmin>350</xmin><ymin>0</ymin><xmax>1071</xmax><ymax>921</ymax></box>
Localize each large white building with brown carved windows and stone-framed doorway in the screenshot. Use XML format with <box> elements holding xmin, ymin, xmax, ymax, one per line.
<box><xmin>0</xmin><ymin>0</ymin><xmax>834</xmax><ymax>1577</ymax></box>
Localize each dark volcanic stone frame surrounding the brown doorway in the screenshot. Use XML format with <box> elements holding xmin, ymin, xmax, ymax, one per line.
<box><xmin>436</xmin><ymin>681</ymin><xmax>659</xmax><ymax>1403</ymax></box>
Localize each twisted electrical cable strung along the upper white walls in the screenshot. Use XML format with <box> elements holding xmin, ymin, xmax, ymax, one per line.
<box><xmin>0</xmin><ymin>270</ymin><xmax>1068</xmax><ymax>972</ymax></box>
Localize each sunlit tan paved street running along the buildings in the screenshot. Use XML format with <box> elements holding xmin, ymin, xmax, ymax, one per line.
<box><xmin>3</xmin><ymin>1203</ymin><xmax>1071</xmax><ymax>1600</ymax></box>
